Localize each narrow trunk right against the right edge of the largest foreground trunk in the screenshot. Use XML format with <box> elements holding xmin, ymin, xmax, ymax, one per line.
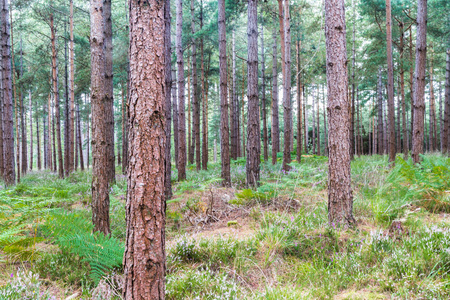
<box><xmin>164</xmin><ymin>0</ymin><xmax>172</xmax><ymax>200</ymax></box>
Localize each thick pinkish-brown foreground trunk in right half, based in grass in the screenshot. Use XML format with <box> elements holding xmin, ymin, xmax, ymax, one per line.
<box><xmin>325</xmin><ymin>0</ymin><xmax>355</xmax><ymax>226</ymax></box>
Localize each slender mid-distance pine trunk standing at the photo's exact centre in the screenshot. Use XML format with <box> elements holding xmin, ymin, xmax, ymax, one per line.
<box><xmin>218</xmin><ymin>0</ymin><xmax>231</xmax><ymax>187</ymax></box>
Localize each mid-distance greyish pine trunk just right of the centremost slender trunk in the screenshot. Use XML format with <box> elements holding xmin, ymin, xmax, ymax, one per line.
<box><xmin>247</xmin><ymin>0</ymin><xmax>261</xmax><ymax>188</ymax></box>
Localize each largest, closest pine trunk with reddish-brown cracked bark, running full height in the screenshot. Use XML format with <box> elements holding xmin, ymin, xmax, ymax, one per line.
<box><xmin>124</xmin><ymin>0</ymin><xmax>166</xmax><ymax>300</ymax></box>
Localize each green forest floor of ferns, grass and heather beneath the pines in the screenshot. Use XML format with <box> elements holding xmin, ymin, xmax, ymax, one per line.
<box><xmin>0</xmin><ymin>154</ymin><xmax>450</xmax><ymax>299</ymax></box>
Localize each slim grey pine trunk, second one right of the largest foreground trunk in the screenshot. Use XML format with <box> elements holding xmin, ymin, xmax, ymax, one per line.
<box><xmin>176</xmin><ymin>0</ymin><xmax>186</xmax><ymax>181</ymax></box>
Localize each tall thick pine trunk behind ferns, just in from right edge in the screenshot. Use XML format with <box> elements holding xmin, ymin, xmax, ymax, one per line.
<box><xmin>412</xmin><ymin>0</ymin><xmax>427</xmax><ymax>163</ymax></box>
